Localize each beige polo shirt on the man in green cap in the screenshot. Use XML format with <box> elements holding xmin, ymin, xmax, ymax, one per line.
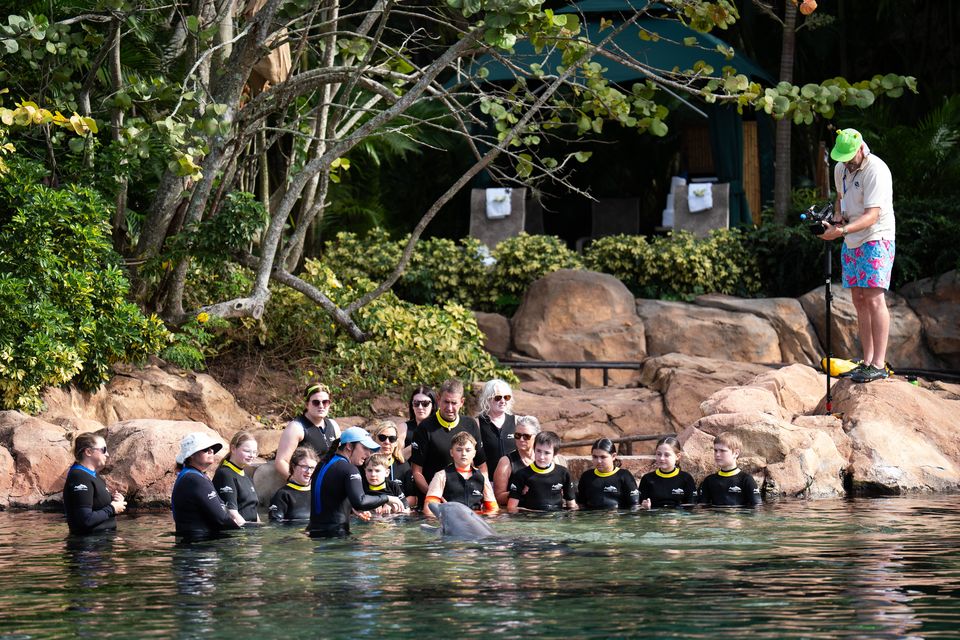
<box><xmin>833</xmin><ymin>154</ymin><xmax>896</xmax><ymax>249</ymax></box>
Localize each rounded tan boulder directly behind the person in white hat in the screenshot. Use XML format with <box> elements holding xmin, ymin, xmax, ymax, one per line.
<box><xmin>103</xmin><ymin>420</ymin><xmax>227</xmax><ymax>506</ymax></box>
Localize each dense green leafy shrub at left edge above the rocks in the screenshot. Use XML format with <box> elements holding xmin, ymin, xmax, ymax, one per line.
<box><xmin>0</xmin><ymin>161</ymin><xmax>168</xmax><ymax>412</ymax></box>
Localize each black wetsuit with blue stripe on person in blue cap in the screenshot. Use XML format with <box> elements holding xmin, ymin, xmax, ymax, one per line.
<box><xmin>307</xmin><ymin>453</ymin><xmax>389</xmax><ymax>538</ymax></box>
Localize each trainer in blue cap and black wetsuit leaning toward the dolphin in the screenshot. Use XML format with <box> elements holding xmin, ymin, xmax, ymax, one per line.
<box><xmin>307</xmin><ymin>427</ymin><xmax>404</xmax><ymax>538</ymax></box>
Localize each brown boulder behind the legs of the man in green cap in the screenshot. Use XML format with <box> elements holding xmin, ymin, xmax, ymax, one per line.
<box><xmin>800</xmin><ymin>285</ymin><xmax>940</xmax><ymax>369</ymax></box>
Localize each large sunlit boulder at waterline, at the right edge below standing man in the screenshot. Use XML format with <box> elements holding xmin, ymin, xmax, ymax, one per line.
<box><xmin>834</xmin><ymin>379</ymin><xmax>960</xmax><ymax>494</ymax></box>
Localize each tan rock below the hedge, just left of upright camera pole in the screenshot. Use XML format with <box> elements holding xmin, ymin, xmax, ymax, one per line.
<box><xmin>694</xmin><ymin>294</ymin><xmax>823</xmax><ymax>364</ymax></box>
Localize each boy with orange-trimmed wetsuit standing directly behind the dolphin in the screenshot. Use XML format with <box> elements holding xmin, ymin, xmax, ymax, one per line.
<box><xmin>423</xmin><ymin>431</ymin><xmax>500</xmax><ymax>517</ymax></box>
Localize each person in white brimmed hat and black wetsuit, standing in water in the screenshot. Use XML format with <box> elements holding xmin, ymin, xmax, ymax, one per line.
<box><xmin>170</xmin><ymin>431</ymin><xmax>243</xmax><ymax>540</ymax></box>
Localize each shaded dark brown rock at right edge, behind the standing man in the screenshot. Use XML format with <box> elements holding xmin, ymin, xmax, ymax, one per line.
<box><xmin>900</xmin><ymin>271</ymin><xmax>960</xmax><ymax>369</ymax></box>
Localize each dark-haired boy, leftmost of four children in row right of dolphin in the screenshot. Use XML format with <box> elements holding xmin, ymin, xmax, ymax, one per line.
<box><xmin>507</xmin><ymin>431</ymin><xmax>577</xmax><ymax>512</ymax></box>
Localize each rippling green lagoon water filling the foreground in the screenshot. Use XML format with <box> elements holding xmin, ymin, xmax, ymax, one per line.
<box><xmin>0</xmin><ymin>496</ymin><xmax>960</xmax><ymax>640</ymax></box>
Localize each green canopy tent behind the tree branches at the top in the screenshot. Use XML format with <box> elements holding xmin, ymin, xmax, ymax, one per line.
<box><xmin>469</xmin><ymin>0</ymin><xmax>773</xmax><ymax>226</ymax></box>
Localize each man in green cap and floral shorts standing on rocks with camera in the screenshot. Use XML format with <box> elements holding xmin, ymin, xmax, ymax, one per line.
<box><xmin>820</xmin><ymin>129</ymin><xmax>896</xmax><ymax>382</ymax></box>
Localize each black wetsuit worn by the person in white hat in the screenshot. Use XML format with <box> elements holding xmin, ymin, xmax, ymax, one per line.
<box><xmin>170</xmin><ymin>467</ymin><xmax>239</xmax><ymax>539</ymax></box>
